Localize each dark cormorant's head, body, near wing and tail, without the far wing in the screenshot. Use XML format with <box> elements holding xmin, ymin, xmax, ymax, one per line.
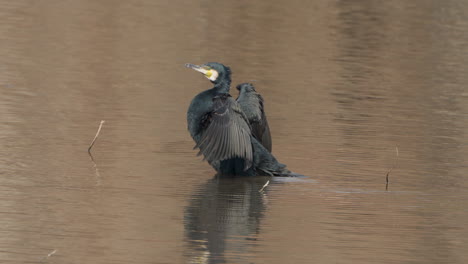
<box><xmin>186</xmin><ymin>62</ymin><xmax>292</xmax><ymax>176</ymax></box>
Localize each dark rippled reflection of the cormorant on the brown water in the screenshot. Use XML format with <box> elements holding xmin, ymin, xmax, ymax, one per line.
<box><xmin>185</xmin><ymin>177</ymin><xmax>269</xmax><ymax>263</ymax></box>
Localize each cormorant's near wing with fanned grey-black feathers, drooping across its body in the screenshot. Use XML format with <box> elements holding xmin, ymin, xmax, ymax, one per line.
<box><xmin>195</xmin><ymin>94</ymin><xmax>253</xmax><ymax>169</ymax></box>
